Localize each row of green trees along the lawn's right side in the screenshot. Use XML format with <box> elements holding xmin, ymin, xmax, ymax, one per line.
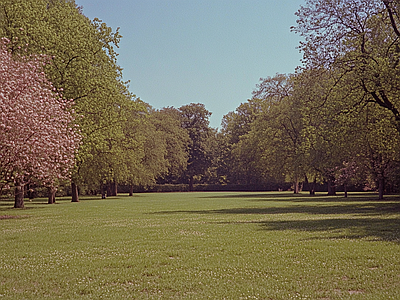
<box><xmin>217</xmin><ymin>0</ymin><xmax>400</xmax><ymax>198</ymax></box>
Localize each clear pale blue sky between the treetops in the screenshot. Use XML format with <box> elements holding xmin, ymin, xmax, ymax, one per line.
<box><xmin>76</xmin><ymin>0</ymin><xmax>304</xmax><ymax>127</ymax></box>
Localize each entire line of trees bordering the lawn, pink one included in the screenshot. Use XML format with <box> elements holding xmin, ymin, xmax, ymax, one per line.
<box><xmin>0</xmin><ymin>0</ymin><xmax>400</xmax><ymax>207</ymax></box>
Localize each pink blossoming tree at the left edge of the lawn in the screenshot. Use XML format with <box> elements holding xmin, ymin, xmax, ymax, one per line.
<box><xmin>0</xmin><ymin>39</ymin><xmax>80</xmax><ymax>208</ymax></box>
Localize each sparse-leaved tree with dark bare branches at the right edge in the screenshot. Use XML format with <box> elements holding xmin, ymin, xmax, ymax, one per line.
<box><xmin>293</xmin><ymin>0</ymin><xmax>400</xmax><ymax>198</ymax></box>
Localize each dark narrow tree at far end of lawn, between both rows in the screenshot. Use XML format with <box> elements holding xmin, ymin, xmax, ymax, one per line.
<box><xmin>179</xmin><ymin>103</ymin><xmax>211</xmax><ymax>191</ymax></box>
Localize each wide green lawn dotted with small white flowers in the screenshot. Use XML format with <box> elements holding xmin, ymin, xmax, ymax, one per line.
<box><xmin>0</xmin><ymin>192</ymin><xmax>400</xmax><ymax>299</ymax></box>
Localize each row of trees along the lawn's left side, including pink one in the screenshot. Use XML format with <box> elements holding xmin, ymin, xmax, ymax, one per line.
<box><xmin>0</xmin><ymin>0</ymin><xmax>202</xmax><ymax>207</ymax></box>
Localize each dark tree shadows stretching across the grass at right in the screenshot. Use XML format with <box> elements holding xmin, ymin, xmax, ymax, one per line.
<box><xmin>152</xmin><ymin>202</ymin><xmax>400</xmax><ymax>243</ymax></box>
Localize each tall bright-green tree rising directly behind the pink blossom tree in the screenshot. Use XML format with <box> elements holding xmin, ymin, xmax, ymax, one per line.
<box><xmin>0</xmin><ymin>0</ymin><xmax>142</xmax><ymax>201</ymax></box>
